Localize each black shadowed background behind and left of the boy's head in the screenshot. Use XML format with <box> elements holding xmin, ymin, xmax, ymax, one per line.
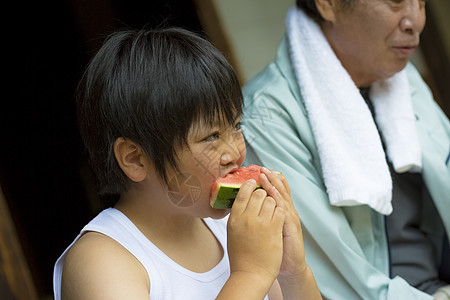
<box><xmin>0</xmin><ymin>0</ymin><xmax>202</xmax><ymax>297</ymax></box>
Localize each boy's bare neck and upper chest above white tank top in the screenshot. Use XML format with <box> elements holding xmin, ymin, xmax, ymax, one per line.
<box><xmin>115</xmin><ymin>191</ymin><xmax>224</xmax><ymax>272</ymax></box>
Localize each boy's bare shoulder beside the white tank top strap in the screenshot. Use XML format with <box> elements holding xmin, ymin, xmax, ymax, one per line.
<box><xmin>62</xmin><ymin>231</ymin><xmax>150</xmax><ymax>299</ymax></box>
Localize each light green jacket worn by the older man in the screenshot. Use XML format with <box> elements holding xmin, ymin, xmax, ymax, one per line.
<box><xmin>243</xmin><ymin>40</ymin><xmax>450</xmax><ymax>300</ymax></box>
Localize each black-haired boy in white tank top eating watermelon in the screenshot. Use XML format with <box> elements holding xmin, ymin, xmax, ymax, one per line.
<box><xmin>54</xmin><ymin>28</ymin><xmax>320</xmax><ymax>300</ymax></box>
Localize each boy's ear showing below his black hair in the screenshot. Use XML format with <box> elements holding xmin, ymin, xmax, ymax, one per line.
<box><xmin>114</xmin><ymin>137</ymin><xmax>148</xmax><ymax>182</ymax></box>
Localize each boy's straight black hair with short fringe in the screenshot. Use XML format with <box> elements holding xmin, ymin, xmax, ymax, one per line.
<box><xmin>77</xmin><ymin>28</ymin><xmax>243</xmax><ymax>199</ymax></box>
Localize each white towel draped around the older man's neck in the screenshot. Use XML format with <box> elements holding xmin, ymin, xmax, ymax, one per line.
<box><xmin>286</xmin><ymin>7</ymin><xmax>421</xmax><ymax>215</ymax></box>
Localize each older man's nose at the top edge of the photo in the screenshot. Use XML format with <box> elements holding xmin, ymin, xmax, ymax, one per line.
<box><xmin>400</xmin><ymin>0</ymin><xmax>425</xmax><ymax>34</ymax></box>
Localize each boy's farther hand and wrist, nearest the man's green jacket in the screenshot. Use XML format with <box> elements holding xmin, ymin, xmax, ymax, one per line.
<box><xmin>259</xmin><ymin>168</ymin><xmax>307</xmax><ymax>278</ymax></box>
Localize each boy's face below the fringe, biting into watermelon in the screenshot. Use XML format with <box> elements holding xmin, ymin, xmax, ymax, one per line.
<box><xmin>164</xmin><ymin>120</ymin><xmax>246</xmax><ymax>218</ymax></box>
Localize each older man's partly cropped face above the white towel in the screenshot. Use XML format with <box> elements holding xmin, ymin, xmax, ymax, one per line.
<box><xmin>316</xmin><ymin>0</ymin><xmax>425</xmax><ymax>87</ymax></box>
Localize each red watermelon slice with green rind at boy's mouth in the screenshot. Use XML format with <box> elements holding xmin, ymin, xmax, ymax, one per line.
<box><xmin>210</xmin><ymin>165</ymin><xmax>280</xmax><ymax>209</ymax></box>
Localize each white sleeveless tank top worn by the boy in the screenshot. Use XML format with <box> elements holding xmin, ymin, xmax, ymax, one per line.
<box><xmin>53</xmin><ymin>208</ymin><xmax>239</xmax><ymax>300</ymax></box>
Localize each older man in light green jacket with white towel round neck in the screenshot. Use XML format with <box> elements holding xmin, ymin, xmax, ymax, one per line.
<box><xmin>243</xmin><ymin>0</ymin><xmax>450</xmax><ymax>299</ymax></box>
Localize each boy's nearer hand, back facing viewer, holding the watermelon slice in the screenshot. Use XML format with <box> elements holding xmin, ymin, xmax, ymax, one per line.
<box><xmin>228</xmin><ymin>180</ymin><xmax>285</xmax><ymax>288</ymax></box>
